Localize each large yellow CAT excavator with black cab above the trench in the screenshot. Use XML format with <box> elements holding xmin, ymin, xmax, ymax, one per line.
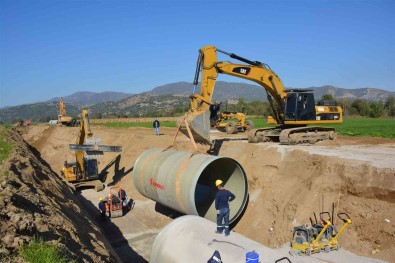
<box><xmin>178</xmin><ymin>46</ymin><xmax>342</xmax><ymax>144</ymax></box>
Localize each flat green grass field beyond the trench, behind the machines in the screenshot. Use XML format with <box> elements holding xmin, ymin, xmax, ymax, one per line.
<box><xmin>98</xmin><ymin>118</ymin><xmax>395</xmax><ymax>139</ymax></box>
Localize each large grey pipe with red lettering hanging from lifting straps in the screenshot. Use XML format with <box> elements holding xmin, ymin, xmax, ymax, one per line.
<box><xmin>133</xmin><ymin>148</ymin><xmax>248</xmax><ymax>223</ymax></box>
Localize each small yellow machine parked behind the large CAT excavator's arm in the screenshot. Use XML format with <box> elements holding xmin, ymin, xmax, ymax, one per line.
<box><xmin>210</xmin><ymin>103</ymin><xmax>254</xmax><ymax>134</ymax></box>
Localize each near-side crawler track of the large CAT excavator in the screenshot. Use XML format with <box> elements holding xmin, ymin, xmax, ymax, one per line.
<box><xmin>279</xmin><ymin>126</ymin><xmax>336</xmax><ymax>145</ymax></box>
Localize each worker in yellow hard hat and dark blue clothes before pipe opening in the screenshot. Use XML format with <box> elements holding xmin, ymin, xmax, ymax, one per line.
<box><xmin>215</xmin><ymin>180</ymin><xmax>236</xmax><ymax>236</ymax></box>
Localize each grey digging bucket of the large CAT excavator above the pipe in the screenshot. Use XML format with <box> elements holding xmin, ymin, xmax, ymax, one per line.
<box><xmin>177</xmin><ymin>110</ymin><xmax>212</xmax><ymax>145</ymax></box>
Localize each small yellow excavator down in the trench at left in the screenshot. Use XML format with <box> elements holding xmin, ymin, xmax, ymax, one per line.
<box><xmin>61</xmin><ymin>109</ymin><xmax>122</xmax><ymax>192</ymax></box>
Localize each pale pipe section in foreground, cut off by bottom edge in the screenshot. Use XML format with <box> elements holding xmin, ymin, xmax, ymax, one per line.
<box><xmin>149</xmin><ymin>215</ymin><xmax>322</xmax><ymax>263</ymax></box>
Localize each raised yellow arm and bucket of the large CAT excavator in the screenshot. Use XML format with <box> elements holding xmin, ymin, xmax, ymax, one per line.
<box><xmin>181</xmin><ymin>46</ymin><xmax>286</xmax><ymax>143</ymax></box>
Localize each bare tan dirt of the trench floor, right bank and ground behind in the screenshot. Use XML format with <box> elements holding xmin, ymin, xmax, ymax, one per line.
<box><xmin>5</xmin><ymin>125</ymin><xmax>395</xmax><ymax>262</ymax></box>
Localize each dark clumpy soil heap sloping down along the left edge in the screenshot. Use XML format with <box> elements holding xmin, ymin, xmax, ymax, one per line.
<box><xmin>0</xmin><ymin>128</ymin><xmax>117</xmax><ymax>262</ymax></box>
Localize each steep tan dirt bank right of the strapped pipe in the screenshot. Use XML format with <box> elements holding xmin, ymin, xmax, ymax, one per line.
<box><xmin>221</xmin><ymin>142</ymin><xmax>395</xmax><ymax>261</ymax></box>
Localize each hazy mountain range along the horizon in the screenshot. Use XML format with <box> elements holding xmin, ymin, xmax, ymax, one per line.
<box><xmin>0</xmin><ymin>81</ymin><xmax>395</xmax><ymax>123</ymax></box>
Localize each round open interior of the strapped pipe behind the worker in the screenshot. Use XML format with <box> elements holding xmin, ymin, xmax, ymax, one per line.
<box><xmin>195</xmin><ymin>158</ymin><xmax>247</xmax><ymax>222</ymax></box>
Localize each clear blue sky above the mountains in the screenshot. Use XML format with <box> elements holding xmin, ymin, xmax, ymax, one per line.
<box><xmin>0</xmin><ymin>0</ymin><xmax>395</xmax><ymax>107</ymax></box>
